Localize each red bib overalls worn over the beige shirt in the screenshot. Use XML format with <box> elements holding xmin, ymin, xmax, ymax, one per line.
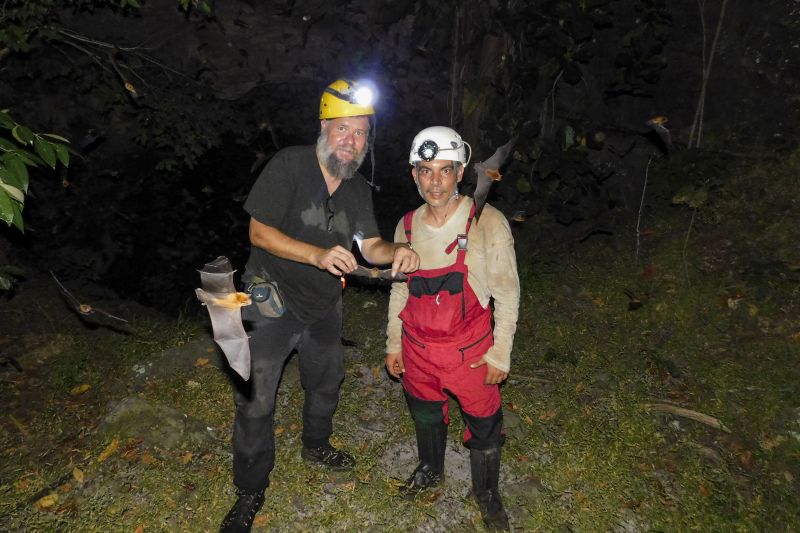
<box><xmin>399</xmin><ymin>204</ymin><xmax>502</xmax><ymax>449</ymax></box>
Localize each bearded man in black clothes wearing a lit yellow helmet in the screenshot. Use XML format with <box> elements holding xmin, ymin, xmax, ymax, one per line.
<box><xmin>221</xmin><ymin>80</ymin><xmax>419</xmax><ymax>532</ymax></box>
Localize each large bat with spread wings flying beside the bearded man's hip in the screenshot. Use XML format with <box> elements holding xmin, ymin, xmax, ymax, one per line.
<box><xmin>194</xmin><ymin>256</ymin><xmax>251</xmax><ymax>381</ymax></box>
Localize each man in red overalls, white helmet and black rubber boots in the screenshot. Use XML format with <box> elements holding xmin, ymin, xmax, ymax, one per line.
<box><xmin>386</xmin><ymin>126</ymin><xmax>519</xmax><ymax>531</ymax></box>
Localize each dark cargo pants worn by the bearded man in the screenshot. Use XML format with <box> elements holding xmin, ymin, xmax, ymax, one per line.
<box><xmin>233</xmin><ymin>300</ymin><xmax>344</xmax><ymax>490</ymax></box>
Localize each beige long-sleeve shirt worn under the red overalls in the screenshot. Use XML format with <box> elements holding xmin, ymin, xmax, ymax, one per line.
<box><xmin>386</xmin><ymin>197</ymin><xmax>519</xmax><ymax>372</ymax></box>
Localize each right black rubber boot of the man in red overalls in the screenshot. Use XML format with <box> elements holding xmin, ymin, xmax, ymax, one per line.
<box><xmin>469</xmin><ymin>448</ymin><xmax>509</xmax><ymax>531</ymax></box>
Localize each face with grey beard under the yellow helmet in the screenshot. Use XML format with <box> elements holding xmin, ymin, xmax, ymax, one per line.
<box><xmin>317</xmin><ymin>117</ymin><xmax>369</xmax><ymax>180</ymax></box>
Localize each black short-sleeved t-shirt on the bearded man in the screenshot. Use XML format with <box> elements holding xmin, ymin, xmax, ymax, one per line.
<box><xmin>244</xmin><ymin>146</ymin><xmax>379</xmax><ymax>322</ymax></box>
